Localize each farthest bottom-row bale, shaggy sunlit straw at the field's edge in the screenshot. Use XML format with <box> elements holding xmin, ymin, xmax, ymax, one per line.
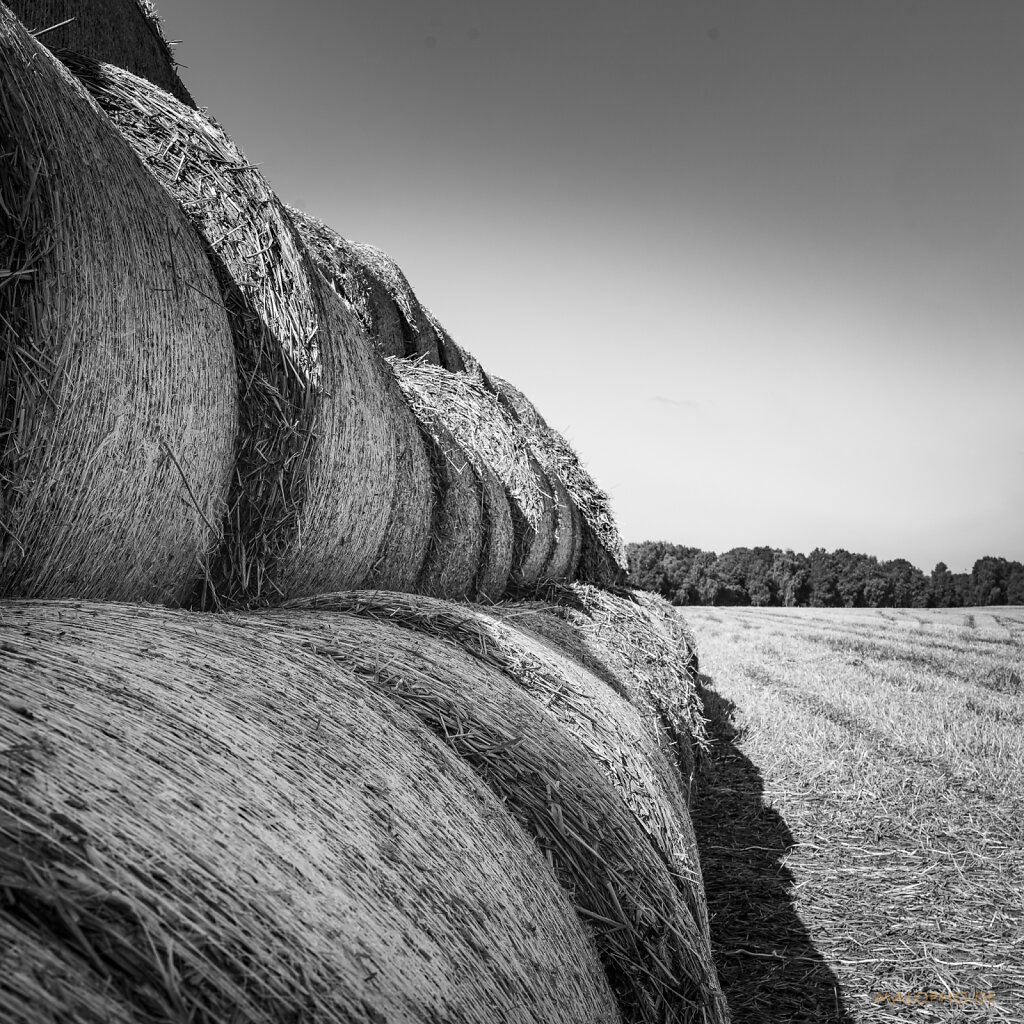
<box><xmin>499</xmin><ymin>584</ymin><xmax>708</xmax><ymax>800</ymax></box>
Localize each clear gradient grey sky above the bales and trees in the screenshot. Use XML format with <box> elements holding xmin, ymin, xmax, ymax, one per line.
<box><xmin>159</xmin><ymin>0</ymin><xmax>1024</xmax><ymax>571</ymax></box>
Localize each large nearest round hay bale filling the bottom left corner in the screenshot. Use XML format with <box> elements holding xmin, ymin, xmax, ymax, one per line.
<box><xmin>0</xmin><ymin>603</ymin><xmax>620</xmax><ymax>1024</ymax></box>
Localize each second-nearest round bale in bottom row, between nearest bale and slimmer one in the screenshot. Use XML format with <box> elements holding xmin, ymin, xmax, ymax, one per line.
<box><xmin>270</xmin><ymin>595</ymin><xmax>728</xmax><ymax>1024</ymax></box>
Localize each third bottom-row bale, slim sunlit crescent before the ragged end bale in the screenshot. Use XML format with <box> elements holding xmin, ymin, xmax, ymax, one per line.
<box><xmin>289</xmin><ymin>591</ymin><xmax>710</xmax><ymax>956</ymax></box>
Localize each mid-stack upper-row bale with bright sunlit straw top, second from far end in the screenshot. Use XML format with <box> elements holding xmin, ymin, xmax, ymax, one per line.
<box><xmin>390</xmin><ymin>359</ymin><xmax>555</xmax><ymax>585</ymax></box>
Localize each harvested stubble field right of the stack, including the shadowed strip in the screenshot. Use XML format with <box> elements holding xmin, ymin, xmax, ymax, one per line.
<box><xmin>681</xmin><ymin>607</ymin><xmax>1024</xmax><ymax>1024</ymax></box>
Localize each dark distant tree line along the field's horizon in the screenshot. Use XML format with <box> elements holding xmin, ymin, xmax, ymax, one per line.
<box><xmin>627</xmin><ymin>541</ymin><xmax>1024</xmax><ymax>608</ymax></box>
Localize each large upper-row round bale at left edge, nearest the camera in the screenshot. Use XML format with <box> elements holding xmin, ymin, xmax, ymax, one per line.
<box><xmin>0</xmin><ymin>12</ymin><xmax>239</xmax><ymax>604</ymax></box>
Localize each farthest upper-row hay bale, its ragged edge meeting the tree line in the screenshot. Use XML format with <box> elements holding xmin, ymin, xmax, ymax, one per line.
<box><xmin>492</xmin><ymin>378</ymin><xmax>629</xmax><ymax>587</ymax></box>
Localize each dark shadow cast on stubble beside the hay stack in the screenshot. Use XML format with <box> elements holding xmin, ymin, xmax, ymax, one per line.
<box><xmin>692</xmin><ymin>676</ymin><xmax>854</xmax><ymax>1024</ymax></box>
